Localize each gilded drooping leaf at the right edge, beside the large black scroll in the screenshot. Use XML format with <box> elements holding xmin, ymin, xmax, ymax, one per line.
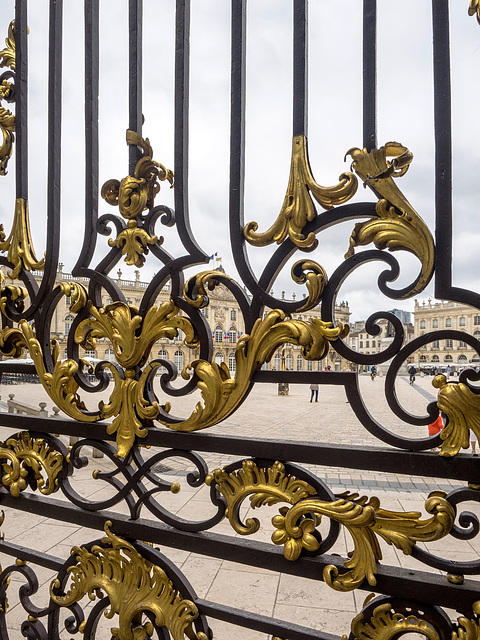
<box><xmin>432</xmin><ymin>374</ymin><xmax>480</xmax><ymax>457</ymax></box>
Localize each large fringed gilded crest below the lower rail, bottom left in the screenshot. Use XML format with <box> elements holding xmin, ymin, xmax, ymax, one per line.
<box><xmin>50</xmin><ymin>521</ymin><xmax>209</xmax><ymax>640</ymax></box>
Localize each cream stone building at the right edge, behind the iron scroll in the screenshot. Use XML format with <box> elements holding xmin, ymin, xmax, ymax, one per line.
<box><xmin>414</xmin><ymin>299</ymin><xmax>480</xmax><ymax>372</ymax></box>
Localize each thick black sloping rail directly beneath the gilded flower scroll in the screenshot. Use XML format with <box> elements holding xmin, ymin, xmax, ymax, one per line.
<box><xmin>0</xmin><ymin>492</ymin><xmax>478</xmax><ymax>612</ymax></box>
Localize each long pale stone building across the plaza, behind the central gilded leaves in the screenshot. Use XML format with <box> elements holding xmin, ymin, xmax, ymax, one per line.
<box><xmin>5</xmin><ymin>264</ymin><xmax>350</xmax><ymax>376</ymax></box>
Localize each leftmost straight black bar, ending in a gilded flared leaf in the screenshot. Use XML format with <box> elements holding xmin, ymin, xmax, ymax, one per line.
<box><xmin>15</xmin><ymin>0</ymin><xmax>28</xmax><ymax>200</ymax></box>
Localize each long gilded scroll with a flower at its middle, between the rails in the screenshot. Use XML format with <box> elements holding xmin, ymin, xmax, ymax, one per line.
<box><xmin>207</xmin><ymin>460</ymin><xmax>455</xmax><ymax>591</ymax></box>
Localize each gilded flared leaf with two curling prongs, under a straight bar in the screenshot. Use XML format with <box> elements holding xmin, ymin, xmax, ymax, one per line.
<box><xmin>243</xmin><ymin>135</ymin><xmax>358</xmax><ymax>249</ymax></box>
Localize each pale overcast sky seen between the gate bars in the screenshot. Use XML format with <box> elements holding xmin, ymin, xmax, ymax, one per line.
<box><xmin>0</xmin><ymin>0</ymin><xmax>480</xmax><ymax>320</ymax></box>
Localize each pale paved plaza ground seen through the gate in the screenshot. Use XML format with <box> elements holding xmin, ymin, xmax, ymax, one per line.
<box><xmin>0</xmin><ymin>376</ymin><xmax>480</xmax><ymax>640</ymax></box>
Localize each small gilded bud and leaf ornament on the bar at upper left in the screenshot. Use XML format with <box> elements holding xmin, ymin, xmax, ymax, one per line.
<box><xmin>101</xmin><ymin>130</ymin><xmax>173</xmax><ymax>268</ymax></box>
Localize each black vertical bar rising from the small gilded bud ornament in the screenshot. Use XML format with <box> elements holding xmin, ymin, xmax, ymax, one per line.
<box><xmin>128</xmin><ymin>0</ymin><xmax>143</xmax><ymax>176</ymax></box>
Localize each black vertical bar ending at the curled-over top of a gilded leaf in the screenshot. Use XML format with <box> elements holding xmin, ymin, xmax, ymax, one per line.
<box><xmin>363</xmin><ymin>0</ymin><xmax>377</xmax><ymax>151</ymax></box>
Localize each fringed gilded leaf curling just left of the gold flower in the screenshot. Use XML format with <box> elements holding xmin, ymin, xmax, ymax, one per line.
<box><xmin>206</xmin><ymin>460</ymin><xmax>315</xmax><ymax>535</ymax></box>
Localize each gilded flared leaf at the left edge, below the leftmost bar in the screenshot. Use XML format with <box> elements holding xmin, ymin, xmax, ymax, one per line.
<box><xmin>0</xmin><ymin>198</ymin><xmax>45</xmax><ymax>280</ymax></box>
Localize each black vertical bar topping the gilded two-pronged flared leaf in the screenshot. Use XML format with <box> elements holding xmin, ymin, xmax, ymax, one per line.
<box><xmin>293</xmin><ymin>0</ymin><xmax>308</xmax><ymax>136</ymax></box>
